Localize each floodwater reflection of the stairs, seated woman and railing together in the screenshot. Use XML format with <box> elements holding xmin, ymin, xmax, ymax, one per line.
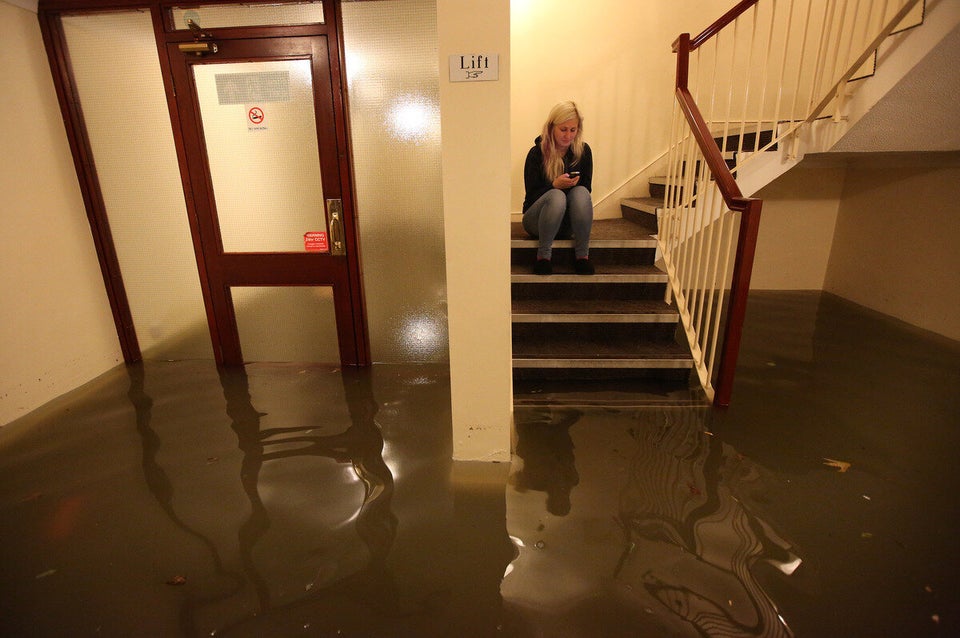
<box><xmin>502</xmin><ymin>408</ymin><xmax>802</xmax><ymax>638</ymax></box>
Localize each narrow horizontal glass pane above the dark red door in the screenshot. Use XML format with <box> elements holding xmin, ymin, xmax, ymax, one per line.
<box><xmin>170</xmin><ymin>2</ymin><xmax>323</xmax><ymax>31</ymax></box>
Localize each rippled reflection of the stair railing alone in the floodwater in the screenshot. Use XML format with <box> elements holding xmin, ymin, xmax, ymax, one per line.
<box><xmin>615</xmin><ymin>411</ymin><xmax>800</xmax><ymax>637</ymax></box>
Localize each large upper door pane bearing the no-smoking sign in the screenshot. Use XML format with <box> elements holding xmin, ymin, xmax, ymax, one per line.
<box><xmin>193</xmin><ymin>60</ymin><xmax>326</xmax><ymax>253</ymax></box>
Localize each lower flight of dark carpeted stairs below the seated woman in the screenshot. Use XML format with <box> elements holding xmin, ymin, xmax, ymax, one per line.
<box><xmin>510</xmin><ymin>198</ymin><xmax>706</xmax><ymax>405</ymax></box>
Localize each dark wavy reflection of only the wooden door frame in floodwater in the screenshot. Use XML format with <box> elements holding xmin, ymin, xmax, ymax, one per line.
<box><xmin>128</xmin><ymin>364</ymin><xmax>399</xmax><ymax>635</ymax></box>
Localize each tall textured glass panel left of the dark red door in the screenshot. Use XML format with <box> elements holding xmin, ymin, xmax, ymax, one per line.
<box><xmin>63</xmin><ymin>11</ymin><xmax>213</xmax><ymax>359</ymax></box>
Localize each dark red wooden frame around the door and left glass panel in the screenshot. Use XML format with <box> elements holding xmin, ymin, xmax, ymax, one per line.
<box><xmin>37</xmin><ymin>0</ymin><xmax>371</xmax><ymax>366</ymax></box>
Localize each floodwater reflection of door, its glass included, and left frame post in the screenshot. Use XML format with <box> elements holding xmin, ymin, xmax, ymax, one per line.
<box><xmin>128</xmin><ymin>366</ymin><xmax>399</xmax><ymax>635</ymax></box>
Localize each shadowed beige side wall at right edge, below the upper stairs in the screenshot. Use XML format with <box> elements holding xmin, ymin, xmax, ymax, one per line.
<box><xmin>823</xmin><ymin>152</ymin><xmax>960</xmax><ymax>339</ymax></box>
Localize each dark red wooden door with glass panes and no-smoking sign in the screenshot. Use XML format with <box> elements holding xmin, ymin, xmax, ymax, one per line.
<box><xmin>167</xmin><ymin>36</ymin><xmax>369</xmax><ymax>365</ymax></box>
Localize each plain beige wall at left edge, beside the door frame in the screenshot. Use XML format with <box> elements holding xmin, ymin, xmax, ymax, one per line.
<box><xmin>0</xmin><ymin>2</ymin><xmax>121</xmax><ymax>424</ymax></box>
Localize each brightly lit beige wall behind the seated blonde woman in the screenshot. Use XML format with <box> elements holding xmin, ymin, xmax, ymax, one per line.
<box><xmin>510</xmin><ymin>0</ymin><xmax>733</xmax><ymax>216</ymax></box>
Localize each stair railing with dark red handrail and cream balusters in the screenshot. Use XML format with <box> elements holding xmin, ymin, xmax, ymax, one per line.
<box><xmin>663</xmin><ymin>0</ymin><xmax>920</xmax><ymax>407</ymax></box>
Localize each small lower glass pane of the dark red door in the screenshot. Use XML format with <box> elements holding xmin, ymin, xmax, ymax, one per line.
<box><xmin>230</xmin><ymin>286</ymin><xmax>340</xmax><ymax>365</ymax></box>
